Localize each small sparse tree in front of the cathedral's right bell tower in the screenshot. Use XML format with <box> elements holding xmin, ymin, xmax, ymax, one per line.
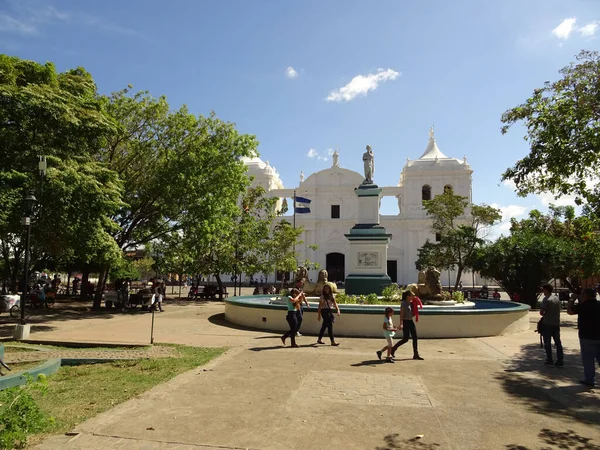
<box><xmin>416</xmin><ymin>191</ymin><xmax>502</xmax><ymax>289</ymax></box>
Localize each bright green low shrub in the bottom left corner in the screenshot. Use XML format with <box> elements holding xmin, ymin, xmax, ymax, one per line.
<box><xmin>0</xmin><ymin>374</ymin><xmax>53</xmax><ymax>449</ymax></box>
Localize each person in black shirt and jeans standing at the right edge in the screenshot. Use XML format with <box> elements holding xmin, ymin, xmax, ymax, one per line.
<box><xmin>567</xmin><ymin>289</ymin><xmax>600</xmax><ymax>387</ymax></box>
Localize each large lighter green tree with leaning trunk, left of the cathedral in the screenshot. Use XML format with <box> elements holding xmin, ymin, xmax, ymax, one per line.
<box><xmin>95</xmin><ymin>89</ymin><xmax>257</xmax><ymax>306</ymax></box>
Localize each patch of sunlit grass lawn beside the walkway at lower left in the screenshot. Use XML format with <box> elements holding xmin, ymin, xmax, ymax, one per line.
<box><xmin>29</xmin><ymin>345</ymin><xmax>225</xmax><ymax>445</ymax></box>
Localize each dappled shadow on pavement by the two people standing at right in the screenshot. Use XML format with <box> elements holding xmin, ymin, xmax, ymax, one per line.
<box><xmin>495</xmin><ymin>343</ymin><xmax>600</xmax><ymax>424</ymax></box>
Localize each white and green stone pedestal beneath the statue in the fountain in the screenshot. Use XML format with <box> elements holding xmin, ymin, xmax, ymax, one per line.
<box><xmin>345</xmin><ymin>183</ymin><xmax>392</xmax><ymax>295</ymax></box>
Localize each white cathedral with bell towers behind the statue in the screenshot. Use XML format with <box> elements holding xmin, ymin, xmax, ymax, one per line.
<box><xmin>244</xmin><ymin>129</ymin><xmax>473</xmax><ymax>284</ymax></box>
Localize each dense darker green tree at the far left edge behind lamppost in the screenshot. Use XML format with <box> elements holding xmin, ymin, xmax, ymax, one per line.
<box><xmin>0</xmin><ymin>55</ymin><xmax>119</xmax><ymax>291</ymax></box>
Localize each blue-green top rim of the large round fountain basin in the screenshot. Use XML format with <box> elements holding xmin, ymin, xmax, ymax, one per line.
<box><xmin>224</xmin><ymin>295</ymin><xmax>531</xmax><ymax>316</ymax></box>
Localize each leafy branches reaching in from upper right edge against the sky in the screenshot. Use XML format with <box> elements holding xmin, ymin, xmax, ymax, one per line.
<box><xmin>502</xmin><ymin>51</ymin><xmax>600</xmax><ymax>204</ymax></box>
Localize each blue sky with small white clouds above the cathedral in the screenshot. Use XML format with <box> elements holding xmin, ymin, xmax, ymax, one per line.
<box><xmin>0</xmin><ymin>0</ymin><xmax>600</xmax><ymax>236</ymax></box>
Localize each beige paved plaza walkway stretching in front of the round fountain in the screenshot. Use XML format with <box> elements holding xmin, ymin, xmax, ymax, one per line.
<box><xmin>0</xmin><ymin>303</ymin><xmax>600</xmax><ymax>450</ymax></box>
